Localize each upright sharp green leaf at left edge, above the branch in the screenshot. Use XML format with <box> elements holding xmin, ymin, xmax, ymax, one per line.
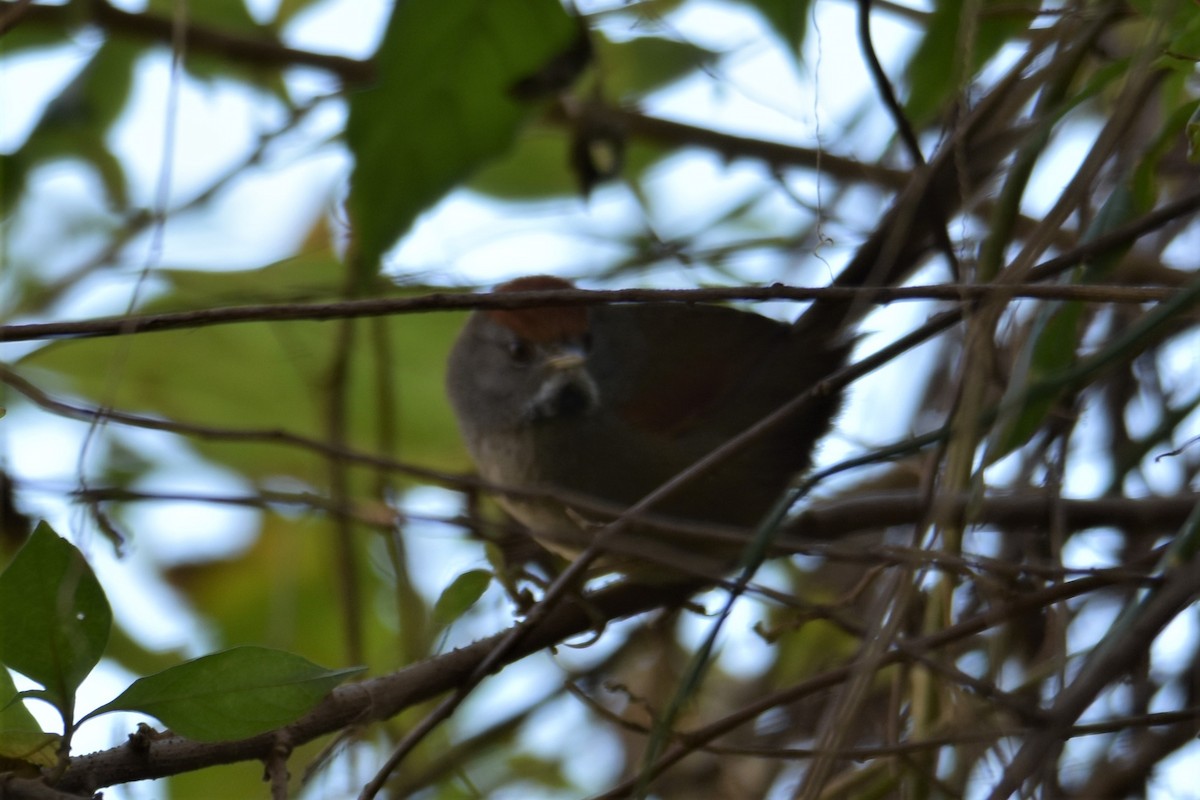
<box><xmin>0</xmin><ymin>522</ymin><xmax>113</xmax><ymax>720</ymax></box>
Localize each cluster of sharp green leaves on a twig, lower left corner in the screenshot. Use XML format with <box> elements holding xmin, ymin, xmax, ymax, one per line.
<box><xmin>0</xmin><ymin>523</ymin><xmax>360</xmax><ymax>764</ymax></box>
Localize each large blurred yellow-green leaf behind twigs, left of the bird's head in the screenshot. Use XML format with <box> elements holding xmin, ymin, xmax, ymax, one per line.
<box><xmin>22</xmin><ymin>266</ymin><xmax>466</xmax><ymax>486</ymax></box>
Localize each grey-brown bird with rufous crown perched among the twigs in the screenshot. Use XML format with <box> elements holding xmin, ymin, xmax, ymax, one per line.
<box><xmin>446</xmin><ymin>275</ymin><xmax>853</xmax><ymax>573</ymax></box>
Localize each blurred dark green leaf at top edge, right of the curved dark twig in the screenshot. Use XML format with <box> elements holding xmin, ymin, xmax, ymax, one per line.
<box><xmin>905</xmin><ymin>0</ymin><xmax>1036</xmax><ymax>127</ymax></box>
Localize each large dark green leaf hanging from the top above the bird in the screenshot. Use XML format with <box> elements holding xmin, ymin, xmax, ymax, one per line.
<box><xmin>346</xmin><ymin>0</ymin><xmax>578</xmax><ymax>278</ymax></box>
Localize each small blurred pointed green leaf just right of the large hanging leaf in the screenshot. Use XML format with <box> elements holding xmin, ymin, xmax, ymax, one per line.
<box><xmin>593</xmin><ymin>32</ymin><xmax>718</xmax><ymax>102</ymax></box>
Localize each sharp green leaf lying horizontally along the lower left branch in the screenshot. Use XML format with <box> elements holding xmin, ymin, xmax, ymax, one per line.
<box><xmin>88</xmin><ymin>646</ymin><xmax>364</xmax><ymax>741</ymax></box>
